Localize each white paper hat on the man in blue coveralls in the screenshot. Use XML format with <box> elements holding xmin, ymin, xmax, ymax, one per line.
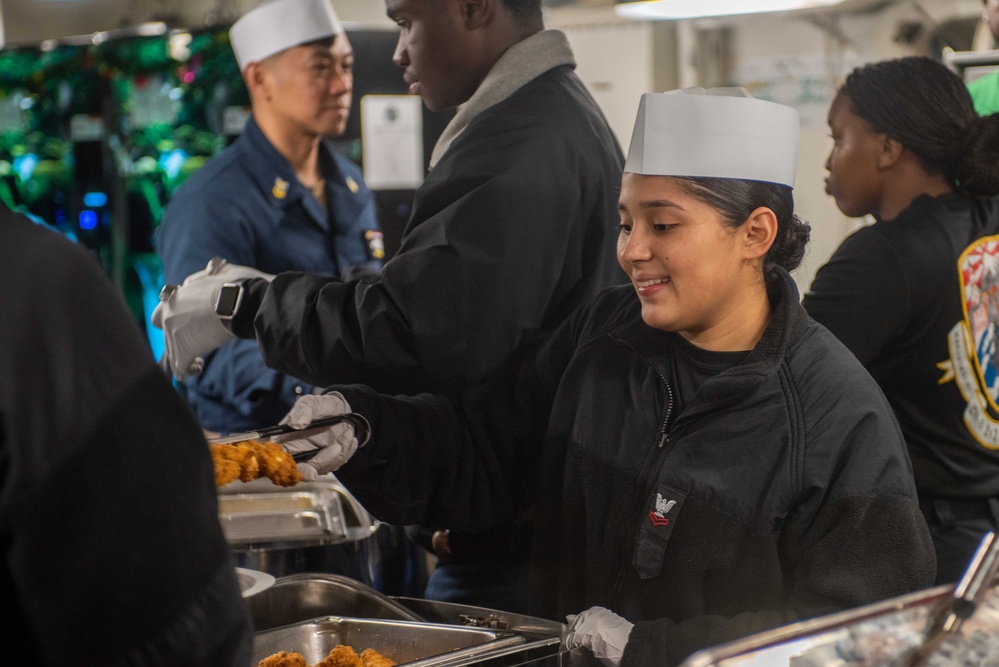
<box><xmin>229</xmin><ymin>0</ymin><xmax>343</xmax><ymax>71</ymax></box>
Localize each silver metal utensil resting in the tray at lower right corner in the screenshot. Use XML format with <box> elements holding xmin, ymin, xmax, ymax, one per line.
<box><xmin>895</xmin><ymin>531</ymin><xmax>999</xmax><ymax>667</ymax></box>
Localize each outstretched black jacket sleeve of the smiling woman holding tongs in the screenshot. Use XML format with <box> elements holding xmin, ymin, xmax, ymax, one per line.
<box><xmin>331</xmin><ymin>298</ymin><xmax>585</xmax><ymax>532</ymax></box>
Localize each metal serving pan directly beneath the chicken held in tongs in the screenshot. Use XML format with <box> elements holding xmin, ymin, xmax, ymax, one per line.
<box><xmin>218</xmin><ymin>475</ymin><xmax>379</xmax><ymax>550</ymax></box>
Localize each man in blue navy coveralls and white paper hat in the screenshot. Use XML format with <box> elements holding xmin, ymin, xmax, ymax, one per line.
<box><xmin>157</xmin><ymin>0</ymin><xmax>384</xmax><ymax>433</ymax></box>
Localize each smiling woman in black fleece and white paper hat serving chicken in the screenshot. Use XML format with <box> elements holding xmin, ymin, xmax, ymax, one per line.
<box><xmin>272</xmin><ymin>94</ymin><xmax>935</xmax><ymax>667</ymax></box>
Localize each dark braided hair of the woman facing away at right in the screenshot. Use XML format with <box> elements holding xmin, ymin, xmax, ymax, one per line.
<box><xmin>840</xmin><ymin>56</ymin><xmax>999</xmax><ymax>196</ymax></box>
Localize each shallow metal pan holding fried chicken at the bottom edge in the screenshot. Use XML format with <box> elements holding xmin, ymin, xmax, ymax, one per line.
<box><xmin>251</xmin><ymin>616</ymin><xmax>527</xmax><ymax>667</ymax></box>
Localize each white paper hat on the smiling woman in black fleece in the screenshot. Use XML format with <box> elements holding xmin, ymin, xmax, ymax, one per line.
<box><xmin>624</xmin><ymin>88</ymin><xmax>800</xmax><ymax>187</ymax></box>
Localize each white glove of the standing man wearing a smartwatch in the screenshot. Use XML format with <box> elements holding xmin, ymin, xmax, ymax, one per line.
<box><xmin>151</xmin><ymin>257</ymin><xmax>274</xmax><ymax>380</ymax></box>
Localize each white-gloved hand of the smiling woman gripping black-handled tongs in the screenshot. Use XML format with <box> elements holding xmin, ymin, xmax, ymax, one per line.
<box><xmin>274</xmin><ymin>391</ymin><xmax>370</xmax><ymax>482</ymax></box>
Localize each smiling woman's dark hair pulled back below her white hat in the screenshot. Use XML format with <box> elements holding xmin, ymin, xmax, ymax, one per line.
<box><xmin>677</xmin><ymin>177</ymin><xmax>812</xmax><ymax>283</ymax></box>
